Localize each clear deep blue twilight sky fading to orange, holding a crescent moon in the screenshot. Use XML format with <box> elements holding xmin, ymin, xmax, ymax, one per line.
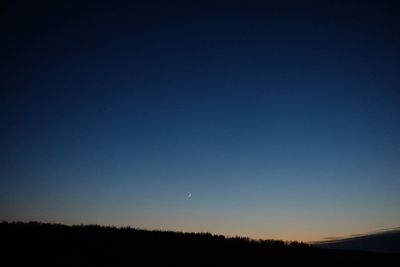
<box><xmin>0</xmin><ymin>1</ymin><xmax>400</xmax><ymax>241</ymax></box>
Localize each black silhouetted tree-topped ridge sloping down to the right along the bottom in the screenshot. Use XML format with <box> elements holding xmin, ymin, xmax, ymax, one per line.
<box><xmin>0</xmin><ymin>222</ymin><xmax>400</xmax><ymax>266</ymax></box>
